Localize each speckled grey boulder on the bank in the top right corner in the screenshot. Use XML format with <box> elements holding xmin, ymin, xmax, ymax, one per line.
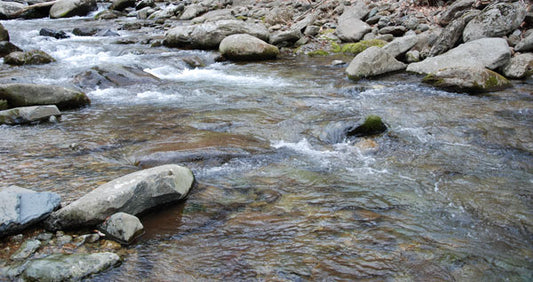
<box><xmin>463</xmin><ymin>1</ymin><xmax>527</xmax><ymax>42</ymax></box>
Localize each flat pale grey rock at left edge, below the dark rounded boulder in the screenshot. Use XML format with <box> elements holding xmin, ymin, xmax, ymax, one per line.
<box><xmin>0</xmin><ymin>105</ymin><xmax>61</xmax><ymax>125</ymax></box>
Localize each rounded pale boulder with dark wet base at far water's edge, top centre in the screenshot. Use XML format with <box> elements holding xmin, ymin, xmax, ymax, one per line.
<box><xmin>219</xmin><ymin>34</ymin><xmax>279</xmax><ymax>61</ymax></box>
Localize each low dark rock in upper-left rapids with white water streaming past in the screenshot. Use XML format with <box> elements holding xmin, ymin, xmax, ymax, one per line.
<box><xmin>74</xmin><ymin>65</ymin><xmax>159</xmax><ymax>89</ymax></box>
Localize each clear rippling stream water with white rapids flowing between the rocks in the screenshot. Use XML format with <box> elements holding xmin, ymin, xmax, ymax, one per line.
<box><xmin>0</xmin><ymin>14</ymin><xmax>533</xmax><ymax>281</ymax></box>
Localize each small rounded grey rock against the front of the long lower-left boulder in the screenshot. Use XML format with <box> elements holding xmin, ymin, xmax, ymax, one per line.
<box><xmin>98</xmin><ymin>212</ymin><xmax>144</xmax><ymax>244</ymax></box>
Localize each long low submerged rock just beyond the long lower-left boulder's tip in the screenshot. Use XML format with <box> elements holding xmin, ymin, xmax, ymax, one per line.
<box><xmin>136</xmin><ymin>148</ymin><xmax>250</xmax><ymax>168</ymax></box>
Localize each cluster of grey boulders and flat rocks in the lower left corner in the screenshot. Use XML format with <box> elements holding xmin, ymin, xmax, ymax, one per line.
<box><xmin>0</xmin><ymin>165</ymin><xmax>195</xmax><ymax>281</ymax></box>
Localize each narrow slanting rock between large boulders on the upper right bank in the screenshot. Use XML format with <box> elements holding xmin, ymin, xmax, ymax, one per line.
<box><xmin>428</xmin><ymin>10</ymin><xmax>480</xmax><ymax>57</ymax></box>
